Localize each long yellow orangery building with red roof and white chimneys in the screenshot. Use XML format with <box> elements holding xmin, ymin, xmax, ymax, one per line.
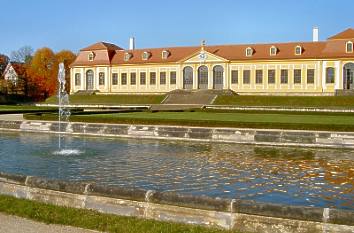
<box><xmin>70</xmin><ymin>28</ymin><xmax>354</xmax><ymax>95</ymax></box>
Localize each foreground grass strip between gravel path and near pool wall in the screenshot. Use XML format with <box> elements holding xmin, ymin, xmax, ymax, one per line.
<box><xmin>0</xmin><ymin>195</ymin><xmax>236</xmax><ymax>233</ymax></box>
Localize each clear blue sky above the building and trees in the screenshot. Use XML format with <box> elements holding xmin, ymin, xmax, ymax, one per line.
<box><xmin>0</xmin><ymin>0</ymin><xmax>354</xmax><ymax>55</ymax></box>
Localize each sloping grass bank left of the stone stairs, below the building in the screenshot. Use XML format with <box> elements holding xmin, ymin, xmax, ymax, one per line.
<box><xmin>45</xmin><ymin>95</ymin><xmax>165</xmax><ymax>105</ymax></box>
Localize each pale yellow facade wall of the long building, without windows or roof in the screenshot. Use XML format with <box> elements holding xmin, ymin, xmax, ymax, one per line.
<box><xmin>71</xmin><ymin>55</ymin><xmax>353</xmax><ymax>94</ymax></box>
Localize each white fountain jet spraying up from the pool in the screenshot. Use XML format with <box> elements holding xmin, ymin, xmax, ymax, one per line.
<box><xmin>54</xmin><ymin>62</ymin><xmax>80</xmax><ymax>155</ymax></box>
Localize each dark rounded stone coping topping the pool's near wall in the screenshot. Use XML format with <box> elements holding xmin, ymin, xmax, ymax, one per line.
<box><xmin>0</xmin><ymin>172</ymin><xmax>354</xmax><ymax>226</ymax></box>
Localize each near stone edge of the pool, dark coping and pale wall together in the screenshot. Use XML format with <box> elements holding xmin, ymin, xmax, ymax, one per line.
<box><xmin>0</xmin><ymin>172</ymin><xmax>354</xmax><ymax>233</ymax></box>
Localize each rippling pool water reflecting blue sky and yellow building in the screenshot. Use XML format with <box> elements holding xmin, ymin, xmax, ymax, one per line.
<box><xmin>0</xmin><ymin>132</ymin><xmax>354</xmax><ymax>210</ymax></box>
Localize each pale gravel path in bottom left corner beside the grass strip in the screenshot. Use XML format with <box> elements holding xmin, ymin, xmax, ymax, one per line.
<box><xmin>0</xmin><ymin>213</ymin><xmax>102</xmax><ymax>233</ymax></box>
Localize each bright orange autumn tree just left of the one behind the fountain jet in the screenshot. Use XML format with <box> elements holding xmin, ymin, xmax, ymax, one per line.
<box><xmin>28</xmin><ymin>47</ymin><xmax>58</xmax><ymax>98</ymax></box>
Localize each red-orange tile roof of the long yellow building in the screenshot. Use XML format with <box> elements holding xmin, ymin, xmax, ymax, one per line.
<box><xmin>72</xmin><ymin>29</ymin><xmax>354</xmax><ymax>66</ymax></box>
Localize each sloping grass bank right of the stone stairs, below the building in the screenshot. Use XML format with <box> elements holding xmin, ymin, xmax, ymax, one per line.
<box><xmin>214</xmin><ymin>96</ymin><xmax>354</xmax><ymax>108</ymax></box>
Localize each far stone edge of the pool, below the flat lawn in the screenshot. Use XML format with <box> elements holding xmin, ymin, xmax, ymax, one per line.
<box><xmin>0</xmin><ymin>120</ymin><xmax>354</xmax><ymax>149</ymax></box>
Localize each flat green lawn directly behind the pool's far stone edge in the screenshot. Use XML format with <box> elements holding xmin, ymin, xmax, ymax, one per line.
<box><xmin>26</xmin><ymin>111</ymin><xmax>354</xmax><ymax>131</ymax></box>
